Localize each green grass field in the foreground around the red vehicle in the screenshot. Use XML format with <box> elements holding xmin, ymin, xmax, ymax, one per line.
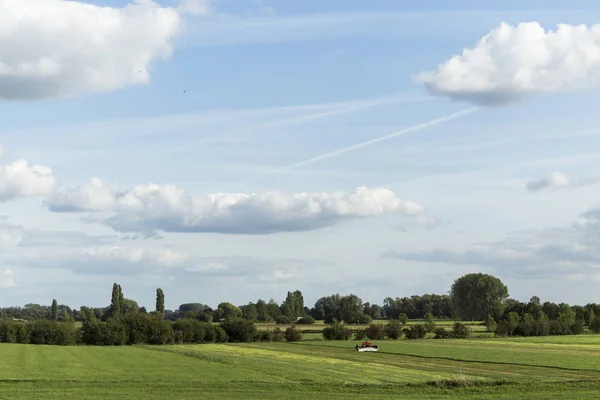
<box><xmin>0</xmin><ymin>335</ymin><xmax>600</xmax><ymax>400</ymax></box>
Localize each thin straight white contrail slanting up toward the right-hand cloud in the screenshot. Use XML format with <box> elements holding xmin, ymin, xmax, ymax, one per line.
<box><xmin>220</xmin><ymin>107</ymin><xmax>479</xmax><ymax>188</ymax></box>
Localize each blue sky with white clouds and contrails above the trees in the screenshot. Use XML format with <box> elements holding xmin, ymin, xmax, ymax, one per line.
<box><xmin>0</xmin><ymin>0</ymin><xmax>600</xmax><ymax>309</ymax></box>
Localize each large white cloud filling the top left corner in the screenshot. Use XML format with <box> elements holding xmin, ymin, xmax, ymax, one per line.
<box><xmin>0</xmin><ymin>0</ymin><xmax>207</xmax><ymax>99</ymax></box>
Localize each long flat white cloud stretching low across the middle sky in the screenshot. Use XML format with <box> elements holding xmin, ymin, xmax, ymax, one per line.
<box><xmin>46</xmin><ymin>179</ymin><xmax>425</xmax><ymax>234</ymax></box>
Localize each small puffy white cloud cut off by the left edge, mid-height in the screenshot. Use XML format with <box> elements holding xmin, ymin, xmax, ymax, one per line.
<box><xmin>0</xmin><ymin>159</ymin><xmax>55</xmax><ymax>203</ymax></box>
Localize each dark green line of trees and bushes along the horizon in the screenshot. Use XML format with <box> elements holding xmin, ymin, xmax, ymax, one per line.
<box><xmin>0</xmin><ymin>274</ymin><xmax>600</xmax><ymax>345</ymax></box>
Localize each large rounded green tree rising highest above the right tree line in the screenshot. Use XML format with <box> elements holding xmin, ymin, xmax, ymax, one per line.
<box><xmin>450</xmin><ymin>273</ymin><xmax>508</xmax><ymax>321</ymax></box>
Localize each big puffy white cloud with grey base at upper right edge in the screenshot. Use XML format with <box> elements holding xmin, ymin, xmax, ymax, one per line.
<box><xmin>417</xmin><ymin>22</ymin><xmax>600</xmax><ymax>105</ymax></box>
